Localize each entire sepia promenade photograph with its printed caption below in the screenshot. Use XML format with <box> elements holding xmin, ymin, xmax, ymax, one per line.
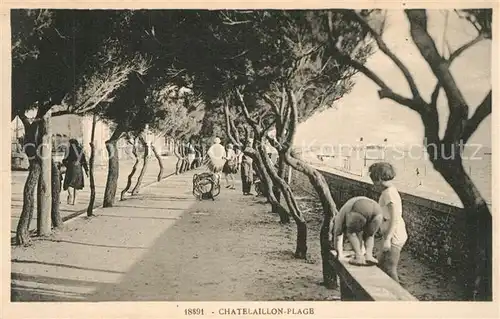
<box><xmin>2</xmin><ymin>1</ymin><xmax>496</xmax><ymax>317</ymax></box>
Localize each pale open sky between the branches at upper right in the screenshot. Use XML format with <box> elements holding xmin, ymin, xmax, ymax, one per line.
<box><xmin>295</xmin><ymin>10</ymin><xmax>491</xmax><ymax>151</ymax></box>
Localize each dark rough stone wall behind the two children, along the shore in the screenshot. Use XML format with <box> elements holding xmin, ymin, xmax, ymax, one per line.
<box><xmin>291</xmin><ymin>171</ymin><xmax>471</xmax><ymax>278</ymax></box>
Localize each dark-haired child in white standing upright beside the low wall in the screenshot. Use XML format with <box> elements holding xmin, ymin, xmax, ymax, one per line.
<box><xmin>368</xmin><ymin>162</ymin><xmax>408</xmax><ymax>282</ymax></box>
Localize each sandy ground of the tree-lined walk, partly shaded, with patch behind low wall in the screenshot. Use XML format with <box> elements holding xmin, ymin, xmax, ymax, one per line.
<box><xmin>11</xmin><ymin>168</ymin><xmax>464</xmax><ymax>301</ymax></box>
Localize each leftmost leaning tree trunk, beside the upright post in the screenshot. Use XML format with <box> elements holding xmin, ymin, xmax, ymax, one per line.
<box><xmin>16</xmin><ymin>158</ymin><xmax>42</xmax><ymax>245</ymax></box>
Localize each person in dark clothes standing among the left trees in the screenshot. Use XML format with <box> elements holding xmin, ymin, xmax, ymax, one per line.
<box><xmin>62</xmin><ymin>139</ymin><xmax>89</xmax><ymax>205</ymax></box>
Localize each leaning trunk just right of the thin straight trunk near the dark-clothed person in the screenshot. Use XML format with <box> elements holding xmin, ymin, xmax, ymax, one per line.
<box><xmin>102</xmin><ymin>127</ymin><xmax>123</xmax><ymax>207</ymax></box>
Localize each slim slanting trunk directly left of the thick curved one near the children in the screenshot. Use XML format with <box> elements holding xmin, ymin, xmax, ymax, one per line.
<box><xmin>257</xmin><ymin>144</ymin><xmax>307</xmax><ymax>259</ymax></box>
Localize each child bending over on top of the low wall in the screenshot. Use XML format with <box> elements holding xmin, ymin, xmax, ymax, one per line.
<box><xmin>333</xmin><ymin>196</ymin><xmax>382</xmax><ymax>266</ymax></box>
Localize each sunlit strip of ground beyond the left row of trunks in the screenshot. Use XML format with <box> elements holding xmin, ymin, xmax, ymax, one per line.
<box><xmin>10</xmin><ymin>156</ymin><xmax>177</xmax><ymax>237</ymax></box>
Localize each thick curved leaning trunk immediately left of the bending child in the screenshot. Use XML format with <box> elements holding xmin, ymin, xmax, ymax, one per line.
<box><xmin>285</xmin><ymin>152</ymin><xmax>338</xmax><ymax>289</ymax></box>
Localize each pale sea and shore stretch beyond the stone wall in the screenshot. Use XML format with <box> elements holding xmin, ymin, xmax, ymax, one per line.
<box><xmin>301</xmin><ymin>145</ymin><xmax>493</xmax><ymax>206</ymax></box>
